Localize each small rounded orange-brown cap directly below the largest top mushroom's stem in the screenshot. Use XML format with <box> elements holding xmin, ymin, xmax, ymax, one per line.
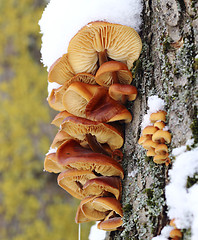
<box><xmin>95</xmin><ymin>61</ymin><xmax>133</xmax><ymax>87</ymax></box>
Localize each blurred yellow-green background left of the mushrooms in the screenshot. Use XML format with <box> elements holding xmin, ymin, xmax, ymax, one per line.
<box><xmin>0</xmin><ymin>0</ymin><xmax>90</xmax><ymax>240</ymax></box>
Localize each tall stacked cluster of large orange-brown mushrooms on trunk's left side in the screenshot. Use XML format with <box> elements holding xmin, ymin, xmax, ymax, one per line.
<box><xmin>44</xmin><ymin>22</ymin><xmax>142</xmax><ymax>231</ymax></box>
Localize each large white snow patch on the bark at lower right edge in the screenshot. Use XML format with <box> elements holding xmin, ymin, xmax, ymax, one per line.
<box><xmin>165</xmin><ymin>141</ymin><xmax>198</xmax><ymax>240</ymax></box>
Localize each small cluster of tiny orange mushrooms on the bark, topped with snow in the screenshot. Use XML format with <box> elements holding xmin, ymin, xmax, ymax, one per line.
<box><xmin>138</xmin><ymin>111</ymin><xmax>171</xmax><ymax>165</ymax></box>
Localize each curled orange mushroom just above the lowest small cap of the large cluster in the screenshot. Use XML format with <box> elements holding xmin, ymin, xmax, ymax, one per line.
<box><xmin>75</xmin><ymin>196</ymin><xmax>123</xmax><ymax>223</ymax></box>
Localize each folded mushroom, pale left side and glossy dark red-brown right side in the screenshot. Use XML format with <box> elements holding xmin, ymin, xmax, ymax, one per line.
<box><xmin>63</xmin><ymin>82</ymin><xmax>132</xmax><ymax>122</ymax></box>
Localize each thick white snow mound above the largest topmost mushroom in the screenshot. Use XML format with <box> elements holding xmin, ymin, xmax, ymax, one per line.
<box><xmin>39</xmin><ymin>0</ymin><xmax>142</xmax><ymax>70</ymax></box>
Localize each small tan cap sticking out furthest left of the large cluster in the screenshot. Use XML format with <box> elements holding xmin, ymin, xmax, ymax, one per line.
<box><xmin>44</xmin><ymin>153</ymin><xmax>65</xmax><ymax>173</ymax></box>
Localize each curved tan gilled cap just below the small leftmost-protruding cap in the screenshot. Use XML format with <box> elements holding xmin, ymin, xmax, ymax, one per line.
<box><xmin>57</xmin><ymin>169</ymin><xmax>96</xmax><ymax>199</ymax></box>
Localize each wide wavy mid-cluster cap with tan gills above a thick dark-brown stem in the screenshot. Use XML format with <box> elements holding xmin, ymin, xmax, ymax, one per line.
<box><xmin>61</xmin><ymin>116</ymin><xmax>124</xmax><ymax>150</ymax></box>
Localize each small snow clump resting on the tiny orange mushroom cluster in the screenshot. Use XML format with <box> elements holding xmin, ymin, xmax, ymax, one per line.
<box><xmin>141</xmin><ymin>95</ymin><xmax>168</xmax><ymax>130</ymax></box>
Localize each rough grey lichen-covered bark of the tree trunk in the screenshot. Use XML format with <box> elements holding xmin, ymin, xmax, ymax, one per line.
<box><xmin>106</xmin><ymin>0</ymin><xmax>198</xmax><ymax>240</ymax></box>
